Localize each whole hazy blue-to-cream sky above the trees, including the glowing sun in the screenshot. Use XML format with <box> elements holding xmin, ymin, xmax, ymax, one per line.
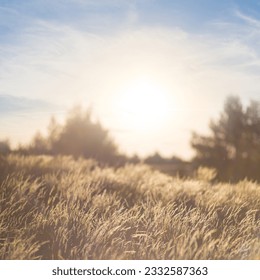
<box><xmin>0</xmin><ymin>0</ymin><xmax>260</xmax><ymax>159</ymax></box>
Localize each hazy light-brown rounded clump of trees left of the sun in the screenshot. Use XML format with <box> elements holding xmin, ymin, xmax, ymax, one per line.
<box><xmin>19</xmin><ymin>107</ymin><xmax>126</xmax><ymax>164</ymax></box>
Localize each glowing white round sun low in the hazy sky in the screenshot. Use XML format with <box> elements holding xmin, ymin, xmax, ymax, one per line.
<box><xmin>117</xmin><ymin>79</ymin><xmax>170</xmax><ymax>132</ymax></box>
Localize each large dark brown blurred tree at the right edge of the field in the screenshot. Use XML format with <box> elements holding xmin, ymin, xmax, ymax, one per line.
<box><xmin>191</xmin><ymin>96</ymin><xmax>260</xmax><ymax>181</ymax></box>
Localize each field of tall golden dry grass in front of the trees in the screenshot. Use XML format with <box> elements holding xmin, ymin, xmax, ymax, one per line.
<box><xmin>0</xmin><ymin>155</ymin><xmax>260</xmax><ymax>260</ymax></box>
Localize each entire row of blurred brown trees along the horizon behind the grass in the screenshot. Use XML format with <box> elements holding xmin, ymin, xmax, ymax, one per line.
<box><xmin>0</xmin><ymin>96</ymin><xmax>260</xmax><ymax>182</ymax></box>
